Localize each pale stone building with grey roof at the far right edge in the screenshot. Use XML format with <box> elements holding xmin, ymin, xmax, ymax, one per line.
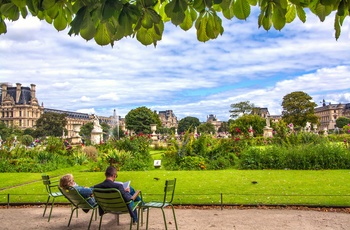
<box><xmin>315</xmin><ymin>100</ymin><xmax>350</xmax><ymax>130</ymax></box>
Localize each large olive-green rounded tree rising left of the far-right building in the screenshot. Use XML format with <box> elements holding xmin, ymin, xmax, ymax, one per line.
<box><xmin>282</xmin><ymin>91</ymin><xmax>319</xmax><ymax>127</ymax></box>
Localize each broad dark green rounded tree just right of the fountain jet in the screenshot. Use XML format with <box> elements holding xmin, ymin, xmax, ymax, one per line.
<box><xmin>125</xmin><ymin>106</ymin><xmax>161</xmax><ymax>134</ymax></box>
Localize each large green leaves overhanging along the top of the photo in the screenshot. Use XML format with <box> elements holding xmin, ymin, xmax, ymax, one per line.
<box><xmin>0</xmin><ymin>0</ymin><xmax>349</xmax><ymax>45</ymax></box>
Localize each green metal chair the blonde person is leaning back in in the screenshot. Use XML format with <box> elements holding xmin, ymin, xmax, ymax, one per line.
<box><xmin>58</xmin><ymin>187</ymin><xmax>98</xmax><ymax>229</ymax></box>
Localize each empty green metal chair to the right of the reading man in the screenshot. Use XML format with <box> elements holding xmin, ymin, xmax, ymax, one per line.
<box><xmin>141</xmin><ymin>178</ymin><xmax>178</xmax><ymax>230</ymax></box>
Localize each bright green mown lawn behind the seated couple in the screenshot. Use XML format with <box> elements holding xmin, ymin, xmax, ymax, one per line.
<box><xmin>0</xmin><ymin>167</ymin><xmax>350</xmax><ymax>206</ymax></box>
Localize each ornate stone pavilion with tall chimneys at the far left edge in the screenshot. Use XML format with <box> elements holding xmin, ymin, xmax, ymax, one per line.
<box><xmin>0</xmin><ymin>83</ymin><xmax>44</xmax><ymax>129</ymax></box>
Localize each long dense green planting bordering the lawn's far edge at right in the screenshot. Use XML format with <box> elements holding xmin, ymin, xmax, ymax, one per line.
<box><xmin>239</xmin><ymin>143</ymin><xmax>350</xmax><ymax>170</ymax></box>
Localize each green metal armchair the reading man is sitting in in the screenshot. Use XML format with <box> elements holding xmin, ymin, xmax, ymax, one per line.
<box><xmin>93</xmin><ymin>188</ymin><xmax>141</xmax><ymax>230</ymax></box>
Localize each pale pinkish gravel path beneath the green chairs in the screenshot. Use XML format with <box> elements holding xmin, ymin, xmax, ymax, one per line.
<box><xmin>0</xmin><ymin>206</ymin><xmax>350</xmax><ymax>230</ymax></box>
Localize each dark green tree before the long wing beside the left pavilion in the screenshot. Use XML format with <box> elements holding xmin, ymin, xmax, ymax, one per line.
<box><xmin>35</xmin><ymin>112</ymin><xmax>67</xmax><ymax>137</ymax></box>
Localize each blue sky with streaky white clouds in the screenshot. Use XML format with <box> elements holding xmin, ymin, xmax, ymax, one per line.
<box><xmin>0</xmin><ymin>10</ymin><xmax>350</xmax><ymax>121</ymax></box>
